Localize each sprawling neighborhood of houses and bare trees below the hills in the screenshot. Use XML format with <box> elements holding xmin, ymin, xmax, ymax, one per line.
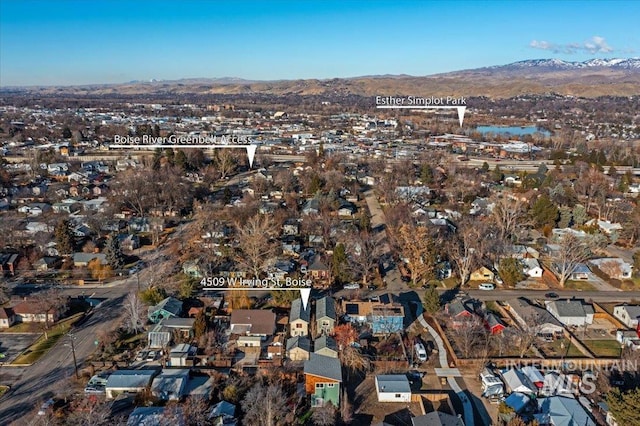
<box><xmin>0</xmin><ymin>88</ymin><xmax>640</xmax><ymax>426</ymax></box>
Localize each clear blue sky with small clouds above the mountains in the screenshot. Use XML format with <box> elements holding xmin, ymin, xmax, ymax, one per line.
<box><xmin>0</xmin><ymin>0</ymin><xmax>640</xmax><ymax>86</ymax></box>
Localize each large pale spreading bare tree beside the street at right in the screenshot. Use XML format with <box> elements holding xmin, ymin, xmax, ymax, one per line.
<box><xmin>543</xmin><ymin>233</ymin><xmax>592</xmax><ymax>286</ymax></box>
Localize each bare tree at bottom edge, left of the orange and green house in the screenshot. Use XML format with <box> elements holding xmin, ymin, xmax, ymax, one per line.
<box><xmin>241</xmin><ymin>383</ymin><xmax>287</xmax><ymax>426</ymax></box>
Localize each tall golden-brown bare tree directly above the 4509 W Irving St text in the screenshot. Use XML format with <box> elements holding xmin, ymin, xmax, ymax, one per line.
<box><xmin>236</xmin><ymin>215</ymin><xmax>278</xmax><ymax>278</ymax></box>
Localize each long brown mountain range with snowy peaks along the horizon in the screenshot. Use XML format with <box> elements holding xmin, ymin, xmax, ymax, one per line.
<box><xmin>2</xmin><ymin>58</ymin><xmax>640</xmax><ymax>98</ymax></box>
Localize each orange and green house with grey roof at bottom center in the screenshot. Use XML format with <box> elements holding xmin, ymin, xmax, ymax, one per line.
<box><xmin>304</xmin><ymin>354</ymin><xmax>342</xmax><ymax>407</ymax></box>
